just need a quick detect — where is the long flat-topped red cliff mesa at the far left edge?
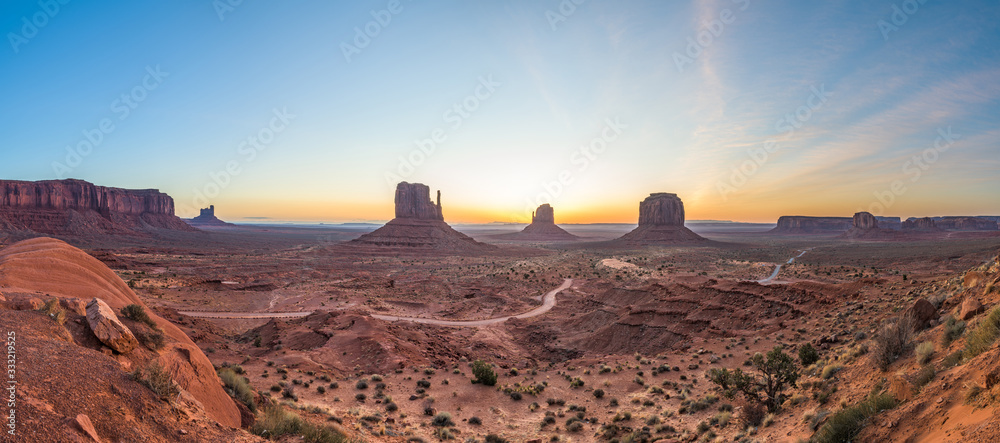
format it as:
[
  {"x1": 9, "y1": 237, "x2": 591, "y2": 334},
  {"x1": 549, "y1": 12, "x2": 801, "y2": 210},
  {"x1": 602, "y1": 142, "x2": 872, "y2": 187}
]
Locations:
[{"x1": 0, "y1": 180, "x2": 196, "y2": 235}]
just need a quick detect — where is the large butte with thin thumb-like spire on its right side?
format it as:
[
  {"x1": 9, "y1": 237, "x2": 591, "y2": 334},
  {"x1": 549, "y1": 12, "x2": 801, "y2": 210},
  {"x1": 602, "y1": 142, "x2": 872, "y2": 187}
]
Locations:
[{"x1": 348, "y1": 182, "x2": 498, "y2": 252}]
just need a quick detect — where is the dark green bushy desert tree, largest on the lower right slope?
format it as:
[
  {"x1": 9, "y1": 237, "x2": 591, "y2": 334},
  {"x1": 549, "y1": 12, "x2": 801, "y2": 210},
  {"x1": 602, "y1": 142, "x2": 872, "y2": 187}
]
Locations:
[{"x1": 708, "y1": 346, "x2": 799, "y2": 413}]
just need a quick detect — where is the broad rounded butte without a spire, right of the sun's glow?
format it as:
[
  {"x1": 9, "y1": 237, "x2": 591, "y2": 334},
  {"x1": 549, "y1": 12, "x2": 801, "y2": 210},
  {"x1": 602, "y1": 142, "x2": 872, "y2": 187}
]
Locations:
[{"x1": 618, "y1": 192, "x2": 706, "y2": 244}]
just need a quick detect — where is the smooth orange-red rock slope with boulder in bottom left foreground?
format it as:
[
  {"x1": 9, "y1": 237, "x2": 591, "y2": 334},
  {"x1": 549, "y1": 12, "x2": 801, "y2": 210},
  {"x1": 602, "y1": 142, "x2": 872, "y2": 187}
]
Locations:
[{"x1": 0, "y1": 238, "x2": 250, "y2": 442}]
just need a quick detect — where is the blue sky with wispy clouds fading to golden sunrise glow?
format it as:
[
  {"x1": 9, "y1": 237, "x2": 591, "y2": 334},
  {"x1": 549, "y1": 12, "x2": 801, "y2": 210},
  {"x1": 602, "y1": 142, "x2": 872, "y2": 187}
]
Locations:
[{"x1": 0, "y1": 0, "x2": 1000, "y2": 223}]
